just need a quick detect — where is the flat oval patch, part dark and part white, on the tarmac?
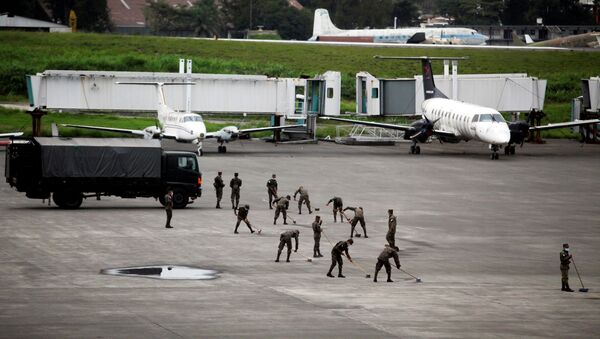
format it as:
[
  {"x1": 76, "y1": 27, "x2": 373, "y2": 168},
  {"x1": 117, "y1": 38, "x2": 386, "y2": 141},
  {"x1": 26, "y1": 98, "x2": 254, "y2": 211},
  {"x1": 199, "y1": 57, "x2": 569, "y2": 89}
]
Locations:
[{"x1": 100, "y1": 265, "x2": 217, "y2": 280}]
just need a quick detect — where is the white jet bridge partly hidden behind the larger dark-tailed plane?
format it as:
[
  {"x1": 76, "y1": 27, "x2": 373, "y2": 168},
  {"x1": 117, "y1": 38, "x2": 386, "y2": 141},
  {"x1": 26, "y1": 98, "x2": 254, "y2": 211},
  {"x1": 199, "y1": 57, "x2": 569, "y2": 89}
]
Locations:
[{"x1": 356, "y1": 72, "x2": 547, "y2": 116}]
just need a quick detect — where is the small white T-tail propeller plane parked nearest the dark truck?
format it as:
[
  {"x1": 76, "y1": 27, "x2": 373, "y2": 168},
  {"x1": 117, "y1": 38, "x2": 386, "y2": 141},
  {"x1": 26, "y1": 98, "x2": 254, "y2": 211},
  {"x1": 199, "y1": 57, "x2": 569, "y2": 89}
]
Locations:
[{"x1": 61, "y1": 82, "x2": 306, "y2": 155}]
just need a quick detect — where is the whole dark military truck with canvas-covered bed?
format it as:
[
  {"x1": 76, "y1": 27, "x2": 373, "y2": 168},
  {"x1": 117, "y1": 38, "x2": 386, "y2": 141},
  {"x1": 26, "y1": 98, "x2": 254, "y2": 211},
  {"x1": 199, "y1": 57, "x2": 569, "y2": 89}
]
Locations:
[{"x1": 5, "y1": 137, "x2": 202, "y2": 209}]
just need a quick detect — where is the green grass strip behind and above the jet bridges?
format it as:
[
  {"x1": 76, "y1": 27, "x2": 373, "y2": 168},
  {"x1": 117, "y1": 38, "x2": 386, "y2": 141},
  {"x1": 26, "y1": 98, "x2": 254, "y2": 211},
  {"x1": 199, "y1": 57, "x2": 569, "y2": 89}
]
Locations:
[{"x1": 0, "y1": 32, "x2": 600, "y2": 103}]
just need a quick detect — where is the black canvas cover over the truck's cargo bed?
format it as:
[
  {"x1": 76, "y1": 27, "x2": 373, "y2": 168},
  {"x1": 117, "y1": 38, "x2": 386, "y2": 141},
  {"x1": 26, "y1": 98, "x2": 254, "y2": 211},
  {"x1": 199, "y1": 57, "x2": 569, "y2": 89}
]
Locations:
[{"x1": 35, "y1": 138, "x2": 162, "y2": 178}]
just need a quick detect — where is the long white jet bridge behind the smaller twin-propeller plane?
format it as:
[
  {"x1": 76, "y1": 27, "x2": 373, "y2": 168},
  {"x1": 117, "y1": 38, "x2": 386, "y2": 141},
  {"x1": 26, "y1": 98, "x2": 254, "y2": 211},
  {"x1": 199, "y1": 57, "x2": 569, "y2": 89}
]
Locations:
[{"x1": 27, "y1": 70, "x2": 341, "y2": 118}]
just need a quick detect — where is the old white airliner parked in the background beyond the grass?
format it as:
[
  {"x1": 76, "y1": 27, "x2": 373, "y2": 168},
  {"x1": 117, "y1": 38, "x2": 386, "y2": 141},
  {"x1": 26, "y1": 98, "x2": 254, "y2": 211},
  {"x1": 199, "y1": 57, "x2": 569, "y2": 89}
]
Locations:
[{"x1": 309, "y1": 8, "x2": 488, "y2": 45}]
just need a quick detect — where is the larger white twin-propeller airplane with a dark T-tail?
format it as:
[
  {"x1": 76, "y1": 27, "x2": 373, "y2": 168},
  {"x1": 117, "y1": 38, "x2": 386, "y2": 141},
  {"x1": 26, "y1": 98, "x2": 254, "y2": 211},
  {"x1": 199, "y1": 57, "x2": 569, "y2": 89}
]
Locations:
[{"x1": 321, "y1": 56, "x2": 600, "y2": 160}]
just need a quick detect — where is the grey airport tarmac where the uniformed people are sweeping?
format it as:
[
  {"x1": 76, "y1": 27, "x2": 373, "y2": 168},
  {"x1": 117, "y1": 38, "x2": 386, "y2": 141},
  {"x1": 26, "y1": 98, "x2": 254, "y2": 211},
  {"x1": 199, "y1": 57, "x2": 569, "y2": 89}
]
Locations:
[{"x1": 0, "y1": 140, "x2": 600, "y2": 338}]
